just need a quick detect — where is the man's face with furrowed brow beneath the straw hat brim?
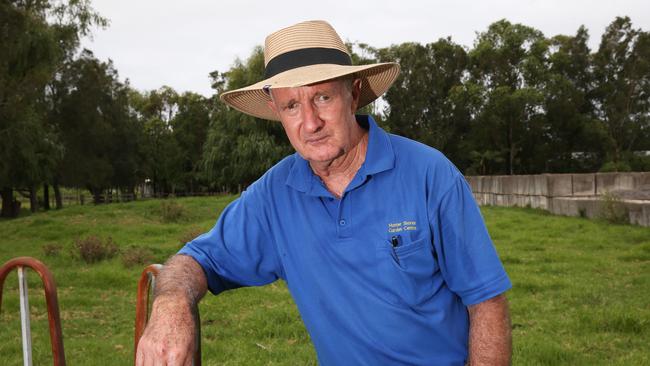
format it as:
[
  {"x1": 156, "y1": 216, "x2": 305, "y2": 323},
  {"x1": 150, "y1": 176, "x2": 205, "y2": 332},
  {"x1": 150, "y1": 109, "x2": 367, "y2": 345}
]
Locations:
[{"x1": 269, "y1": 80, "x2": 361, "y2": 163}]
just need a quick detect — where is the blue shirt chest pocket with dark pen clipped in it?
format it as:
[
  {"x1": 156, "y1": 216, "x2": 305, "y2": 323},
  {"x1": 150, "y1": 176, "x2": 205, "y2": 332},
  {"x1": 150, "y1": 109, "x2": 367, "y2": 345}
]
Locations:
[{"x1": 376, "y1": 237, "x2": 439, "y2": 306}]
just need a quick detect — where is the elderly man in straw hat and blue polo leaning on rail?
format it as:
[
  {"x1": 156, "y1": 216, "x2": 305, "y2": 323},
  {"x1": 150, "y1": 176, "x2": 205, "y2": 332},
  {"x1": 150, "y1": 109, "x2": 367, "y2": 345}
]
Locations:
[{"x1": 137, "y1": 21, "x2": 511, "y2": 365}]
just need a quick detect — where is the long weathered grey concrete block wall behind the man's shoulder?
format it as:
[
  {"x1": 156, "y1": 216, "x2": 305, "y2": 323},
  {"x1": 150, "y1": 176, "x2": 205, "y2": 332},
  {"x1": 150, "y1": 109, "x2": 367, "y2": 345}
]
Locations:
[{"x1": 466, "y1": 172, "x2": 650, "y2": 226}]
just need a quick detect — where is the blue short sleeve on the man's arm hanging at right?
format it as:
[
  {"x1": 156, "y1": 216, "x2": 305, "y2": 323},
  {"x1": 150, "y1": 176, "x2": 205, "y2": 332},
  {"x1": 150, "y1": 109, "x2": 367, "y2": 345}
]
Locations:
[{"x1": 430, "y1": 174, "x2": 512, "y2": 306}]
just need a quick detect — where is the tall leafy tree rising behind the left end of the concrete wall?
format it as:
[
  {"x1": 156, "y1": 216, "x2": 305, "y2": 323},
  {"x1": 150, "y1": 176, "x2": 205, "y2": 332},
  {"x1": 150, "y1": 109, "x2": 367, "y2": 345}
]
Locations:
[{"x1": 464, "y1": 20, "x2": 548, "y2": 174}]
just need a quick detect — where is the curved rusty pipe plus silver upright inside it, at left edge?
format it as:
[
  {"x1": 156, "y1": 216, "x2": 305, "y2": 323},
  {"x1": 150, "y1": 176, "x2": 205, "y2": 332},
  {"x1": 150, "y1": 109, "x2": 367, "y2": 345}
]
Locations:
[{"x1": 0, "y1": 257, "x2": 65, "y2": 366}]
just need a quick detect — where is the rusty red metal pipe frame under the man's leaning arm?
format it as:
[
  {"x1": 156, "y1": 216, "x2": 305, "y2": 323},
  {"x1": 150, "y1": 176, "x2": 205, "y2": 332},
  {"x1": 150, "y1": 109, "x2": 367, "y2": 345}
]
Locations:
[{"x1": 133, "y1": 264, "x2": 201, "y2": 366}]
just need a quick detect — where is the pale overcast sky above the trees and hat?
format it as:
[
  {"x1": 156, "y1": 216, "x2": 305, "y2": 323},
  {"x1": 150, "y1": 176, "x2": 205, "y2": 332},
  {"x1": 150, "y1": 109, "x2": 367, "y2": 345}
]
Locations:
[{"x1": 82, "y1": 0, "x2": 650, "y2": 96}]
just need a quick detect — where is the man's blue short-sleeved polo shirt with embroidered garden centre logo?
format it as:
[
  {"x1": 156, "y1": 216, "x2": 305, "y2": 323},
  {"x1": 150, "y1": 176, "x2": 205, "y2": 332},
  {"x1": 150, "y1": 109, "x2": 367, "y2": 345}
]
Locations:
[{"x1": 180, "y1": 116, "x2": 511, "y2": 365}]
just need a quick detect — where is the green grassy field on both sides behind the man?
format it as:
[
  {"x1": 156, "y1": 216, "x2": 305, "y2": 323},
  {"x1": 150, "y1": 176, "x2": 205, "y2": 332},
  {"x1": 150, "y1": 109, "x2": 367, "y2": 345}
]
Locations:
[{"x1": 0, "y1": 197, "x2": 650, "y2": 365}]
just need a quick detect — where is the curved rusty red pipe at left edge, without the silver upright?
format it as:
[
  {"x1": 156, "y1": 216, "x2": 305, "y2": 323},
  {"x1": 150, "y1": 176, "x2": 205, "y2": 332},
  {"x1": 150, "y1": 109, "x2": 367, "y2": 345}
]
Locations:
[{"x1": 0, "y1": 257, "x2": 65, "y2": 366}]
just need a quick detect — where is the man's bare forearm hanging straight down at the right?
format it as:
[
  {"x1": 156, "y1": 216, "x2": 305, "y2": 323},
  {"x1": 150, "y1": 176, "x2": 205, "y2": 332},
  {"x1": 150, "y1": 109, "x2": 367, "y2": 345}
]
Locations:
[{"x1": 468, "y1": 294, "x2": 512, "y2": 366}]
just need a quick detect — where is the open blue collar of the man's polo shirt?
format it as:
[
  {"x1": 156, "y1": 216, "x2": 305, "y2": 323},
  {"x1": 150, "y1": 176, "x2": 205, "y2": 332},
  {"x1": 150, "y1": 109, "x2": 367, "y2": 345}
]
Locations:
[{"x1": 286, "y1": 115, "x2": 395, "y2": 196}]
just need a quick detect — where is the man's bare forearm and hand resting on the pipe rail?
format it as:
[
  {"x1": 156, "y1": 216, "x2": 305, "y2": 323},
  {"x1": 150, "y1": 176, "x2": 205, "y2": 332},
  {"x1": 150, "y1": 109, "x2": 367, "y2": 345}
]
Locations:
[{"x1": 136, "y1": 255, "x2": 208, "y2": 366}]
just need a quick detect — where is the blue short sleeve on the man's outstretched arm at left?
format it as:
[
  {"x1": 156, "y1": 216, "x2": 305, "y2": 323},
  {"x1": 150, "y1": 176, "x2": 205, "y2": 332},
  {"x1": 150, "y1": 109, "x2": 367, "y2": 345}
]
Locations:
[{"x1": 178, "y1": 187, "x2": 281, "y2": 294}]
